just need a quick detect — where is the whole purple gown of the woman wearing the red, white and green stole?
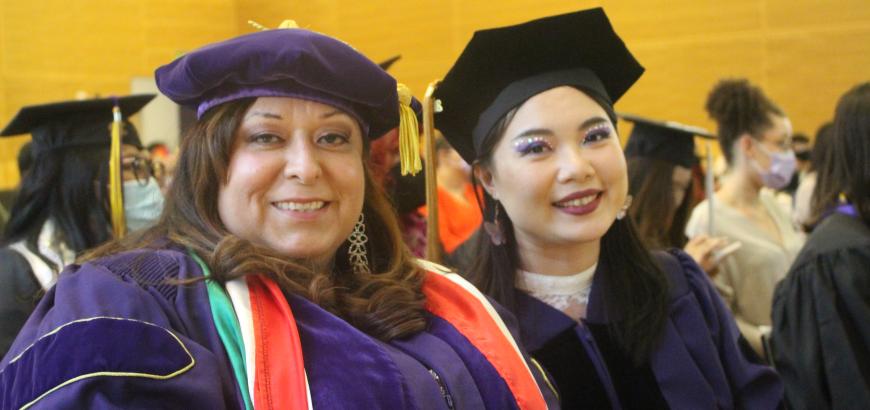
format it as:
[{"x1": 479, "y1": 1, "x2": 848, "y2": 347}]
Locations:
[{"x1": 0, "y1": 250, "x2": 557, "y2": 409}]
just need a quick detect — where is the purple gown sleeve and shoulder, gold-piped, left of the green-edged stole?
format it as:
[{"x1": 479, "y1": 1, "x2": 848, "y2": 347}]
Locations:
[{"x1": 0, "y1": 250, "x2": 242, "y2": 409}]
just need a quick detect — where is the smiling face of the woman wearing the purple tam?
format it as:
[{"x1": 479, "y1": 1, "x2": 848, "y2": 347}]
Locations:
[{"x1": 218, "y1": 97, "x2": 365, "y2": 266}]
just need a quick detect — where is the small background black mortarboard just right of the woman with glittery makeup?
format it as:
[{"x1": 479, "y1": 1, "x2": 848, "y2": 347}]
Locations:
[{"x1": 619, "y1": 113, "x2": 716, "y2": 168}]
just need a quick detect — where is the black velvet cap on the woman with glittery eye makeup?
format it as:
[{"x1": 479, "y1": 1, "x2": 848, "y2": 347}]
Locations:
[{"x1": 434, "y1": 8, "x2": 644, "y2": 163}]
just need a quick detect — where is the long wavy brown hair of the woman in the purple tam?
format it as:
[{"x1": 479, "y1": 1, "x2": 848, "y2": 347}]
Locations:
[{"x1": 83, "y1": 98, "x2": 426, "y2": 340}]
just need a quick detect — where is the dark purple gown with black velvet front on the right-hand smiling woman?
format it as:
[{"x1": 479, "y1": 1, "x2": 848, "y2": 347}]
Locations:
[{"x1": 517, "y1": 251, "x2": 782, "y2": 409}]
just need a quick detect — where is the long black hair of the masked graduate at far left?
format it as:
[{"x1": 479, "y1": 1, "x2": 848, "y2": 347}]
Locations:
[{"x1": 3, "y1": 146, "x2": 111, "y2": 269}]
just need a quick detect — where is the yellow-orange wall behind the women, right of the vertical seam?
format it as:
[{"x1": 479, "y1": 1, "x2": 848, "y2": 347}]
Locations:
[{"x1": 239, "y1": 0, "x2": 870, "y2": 149}]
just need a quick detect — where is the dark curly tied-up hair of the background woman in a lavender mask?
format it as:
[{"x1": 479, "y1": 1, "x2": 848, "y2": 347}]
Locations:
[{"x1": 705, "y1": 78, "x2": 784, "y2": 164}]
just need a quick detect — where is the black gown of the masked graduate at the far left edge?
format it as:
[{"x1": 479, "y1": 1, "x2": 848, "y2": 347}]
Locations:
[{"x1": 0, "y1": 248, "x2": 43, "y2": 357}]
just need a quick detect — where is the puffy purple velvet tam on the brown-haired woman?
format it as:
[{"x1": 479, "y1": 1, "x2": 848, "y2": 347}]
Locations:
[{"x1": 155, "y1": 29, "x2": 399, "y2": 139}]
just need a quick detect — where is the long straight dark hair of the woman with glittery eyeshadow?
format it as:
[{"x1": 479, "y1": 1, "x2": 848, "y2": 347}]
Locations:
[{"x1": 468, "y1": 88, "x2": 668, "y2": 364}]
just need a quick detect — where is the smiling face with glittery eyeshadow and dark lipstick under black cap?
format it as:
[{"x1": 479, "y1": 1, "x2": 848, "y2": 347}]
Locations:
[{"x1": 477, "y1": 87, "x2": 628, "y2": 249}]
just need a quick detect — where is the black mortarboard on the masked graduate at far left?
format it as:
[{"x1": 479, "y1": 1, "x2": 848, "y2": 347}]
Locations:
[{"x1": 0, "y1": 94, "x2": 156, "y2": 155}]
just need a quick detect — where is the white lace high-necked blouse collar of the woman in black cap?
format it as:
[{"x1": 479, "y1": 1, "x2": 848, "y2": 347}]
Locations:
[{"x1": 517, "y1": 264, "x2": 598, "y2": 321}]
